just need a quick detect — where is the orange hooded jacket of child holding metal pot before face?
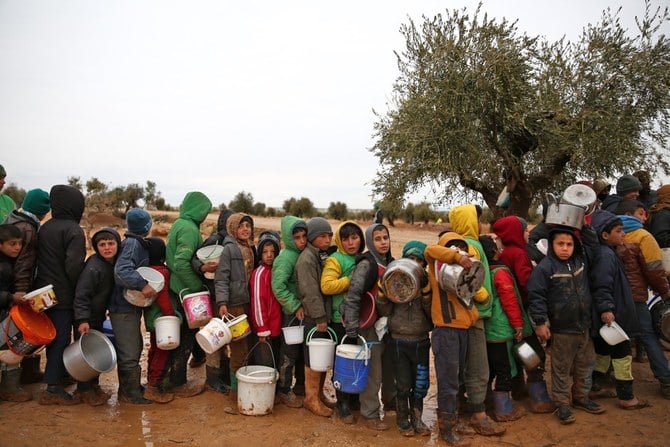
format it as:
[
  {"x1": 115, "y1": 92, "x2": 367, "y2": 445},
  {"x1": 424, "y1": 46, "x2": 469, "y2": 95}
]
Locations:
[{"x1": 425, "y1": 233, "x2": 491, "y2": 329}]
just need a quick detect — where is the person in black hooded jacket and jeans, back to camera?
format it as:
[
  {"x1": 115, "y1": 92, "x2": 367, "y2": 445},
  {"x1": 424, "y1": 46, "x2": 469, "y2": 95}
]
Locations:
[{"x1": 33, "y1": 185, "x2": 86, "y2": 405}]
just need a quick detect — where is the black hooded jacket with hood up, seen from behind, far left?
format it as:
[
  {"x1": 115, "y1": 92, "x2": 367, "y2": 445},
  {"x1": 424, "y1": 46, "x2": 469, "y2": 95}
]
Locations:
[{"x1": 33, "y1": 185, "x2": 86, "y2": 309}]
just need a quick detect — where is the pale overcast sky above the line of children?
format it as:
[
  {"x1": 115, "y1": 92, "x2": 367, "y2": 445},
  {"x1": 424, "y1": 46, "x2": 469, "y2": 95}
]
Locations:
[{"x1": 0, "y1": 0, "x2": 667, "y2": 208}]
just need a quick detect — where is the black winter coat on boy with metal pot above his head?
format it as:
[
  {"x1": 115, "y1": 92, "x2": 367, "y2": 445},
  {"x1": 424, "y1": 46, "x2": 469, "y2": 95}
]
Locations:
[{"x1": 528, "y1": 227, "x2": 592, "y2": 334}]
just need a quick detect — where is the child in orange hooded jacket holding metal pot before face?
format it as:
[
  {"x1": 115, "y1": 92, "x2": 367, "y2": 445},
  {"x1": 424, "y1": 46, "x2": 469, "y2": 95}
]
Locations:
[{"x1": 425, "y1": 232, "x2": 489, "y2": 445}]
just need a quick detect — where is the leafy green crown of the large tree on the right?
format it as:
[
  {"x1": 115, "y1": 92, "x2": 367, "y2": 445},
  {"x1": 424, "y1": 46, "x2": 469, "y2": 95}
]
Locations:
[{"x1": 371, "y1": 2, "x2": 670, "y2": 217}]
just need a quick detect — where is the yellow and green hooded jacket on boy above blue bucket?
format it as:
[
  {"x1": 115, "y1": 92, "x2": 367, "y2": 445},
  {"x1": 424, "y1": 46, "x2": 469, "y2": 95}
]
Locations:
[{"x1": 321, "y1": 220, "x2": 365, "y2": 323}]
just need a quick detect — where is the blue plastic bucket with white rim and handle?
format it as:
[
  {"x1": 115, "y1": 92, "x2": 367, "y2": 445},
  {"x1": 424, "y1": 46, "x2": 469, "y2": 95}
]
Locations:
[{"x1": 333, "y1": 335, "x2": 370, "y2": 394}]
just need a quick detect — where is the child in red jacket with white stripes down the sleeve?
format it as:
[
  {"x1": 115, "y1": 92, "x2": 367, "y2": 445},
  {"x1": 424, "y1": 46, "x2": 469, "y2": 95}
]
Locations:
[{"x1": 249, "y1": 231, "x2": 282, "y2": 369}]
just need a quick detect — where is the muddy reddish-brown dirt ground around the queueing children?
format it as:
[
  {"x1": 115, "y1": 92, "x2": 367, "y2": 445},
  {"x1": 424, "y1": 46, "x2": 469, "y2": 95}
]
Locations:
[{"x1": 0, "y1": 215, "x2": 670, "y2": 447}]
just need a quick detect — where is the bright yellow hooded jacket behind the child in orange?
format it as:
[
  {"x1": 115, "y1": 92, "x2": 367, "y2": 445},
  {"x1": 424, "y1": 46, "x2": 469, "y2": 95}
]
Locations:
[{"x1": 449, "y1": 205, "x2": 493, "y2": 318}]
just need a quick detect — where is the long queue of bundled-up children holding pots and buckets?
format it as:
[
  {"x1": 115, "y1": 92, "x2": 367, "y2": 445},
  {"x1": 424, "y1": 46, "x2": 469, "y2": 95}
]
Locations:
[{"x1": 0, "y1": 164, "x2": 670, "y2": 445}]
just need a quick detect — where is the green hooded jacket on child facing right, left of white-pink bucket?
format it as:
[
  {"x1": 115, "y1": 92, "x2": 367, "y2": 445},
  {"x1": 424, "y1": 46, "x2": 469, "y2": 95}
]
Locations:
[{"x1": 165, "y1": 191, "x2": 212, "y2": 295}]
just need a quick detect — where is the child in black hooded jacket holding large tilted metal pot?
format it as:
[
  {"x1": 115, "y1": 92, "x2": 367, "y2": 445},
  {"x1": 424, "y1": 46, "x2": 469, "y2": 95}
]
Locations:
[{"x1": 74, "y1": 228, "x2": 121, "y2": 406}]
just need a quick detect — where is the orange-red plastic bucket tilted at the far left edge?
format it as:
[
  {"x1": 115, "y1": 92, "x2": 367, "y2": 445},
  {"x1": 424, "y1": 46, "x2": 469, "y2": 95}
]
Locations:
[{"x1": 0, "y1": 304, "x2": 56, "y2": 355}]
